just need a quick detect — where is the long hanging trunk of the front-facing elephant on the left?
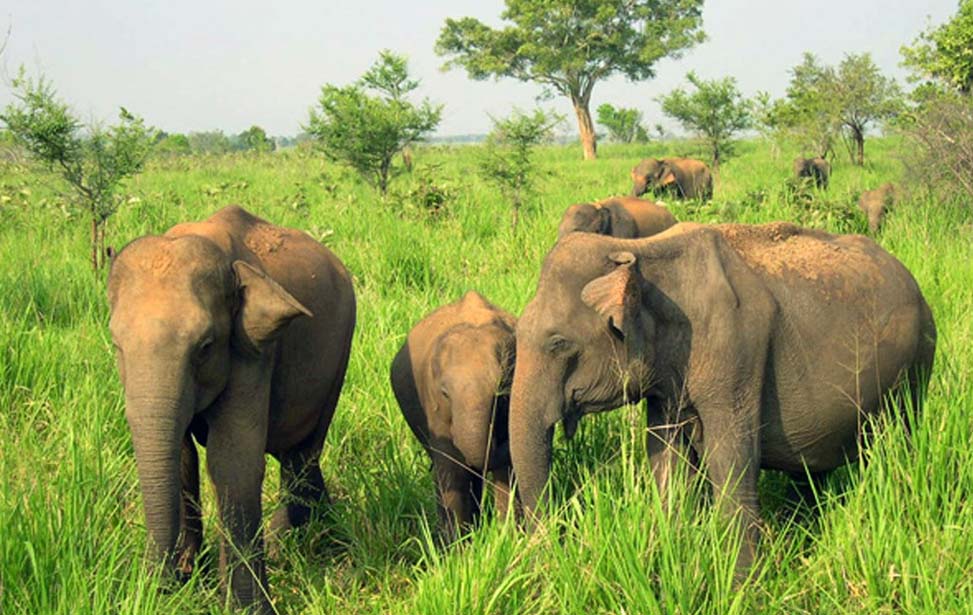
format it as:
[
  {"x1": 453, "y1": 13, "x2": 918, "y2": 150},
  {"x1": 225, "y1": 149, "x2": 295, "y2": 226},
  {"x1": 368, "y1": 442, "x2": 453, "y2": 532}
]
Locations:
[{"x1": 125, "y1": 384, "x2": 192, "y2": 573}]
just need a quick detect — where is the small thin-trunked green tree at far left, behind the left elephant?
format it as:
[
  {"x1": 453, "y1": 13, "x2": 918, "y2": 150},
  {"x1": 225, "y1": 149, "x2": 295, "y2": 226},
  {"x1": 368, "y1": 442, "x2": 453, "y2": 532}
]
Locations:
[{"x1": 0, "y1": 68, "x2": 154, "y2": 269}]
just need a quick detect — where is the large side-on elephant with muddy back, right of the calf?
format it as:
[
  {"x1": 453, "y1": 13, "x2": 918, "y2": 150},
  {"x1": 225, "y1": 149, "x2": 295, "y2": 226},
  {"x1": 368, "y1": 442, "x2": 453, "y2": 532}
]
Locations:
[{"x1": 510, "y1": 223, "x2": 936, "y2": 571}]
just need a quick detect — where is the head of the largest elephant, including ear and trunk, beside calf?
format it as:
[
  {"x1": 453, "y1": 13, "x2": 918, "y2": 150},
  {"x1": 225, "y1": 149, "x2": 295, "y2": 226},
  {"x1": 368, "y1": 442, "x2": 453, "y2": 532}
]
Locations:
[{"x1": 510, "y1": 234, "x2": 655, "y2": 512}]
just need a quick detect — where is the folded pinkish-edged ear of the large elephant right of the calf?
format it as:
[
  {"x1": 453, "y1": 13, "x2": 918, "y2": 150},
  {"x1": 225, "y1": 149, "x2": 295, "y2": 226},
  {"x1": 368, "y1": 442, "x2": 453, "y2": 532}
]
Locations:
[{"x1": 581, "y1": 252, "x2": 642, "y2": 345}]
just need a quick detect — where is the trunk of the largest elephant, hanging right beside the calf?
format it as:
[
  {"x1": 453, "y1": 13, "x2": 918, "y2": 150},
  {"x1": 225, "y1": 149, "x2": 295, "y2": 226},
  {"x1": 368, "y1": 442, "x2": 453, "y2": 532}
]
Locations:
[{"x1": 510, "y1": 355, "x2": 562, "y2": 525}]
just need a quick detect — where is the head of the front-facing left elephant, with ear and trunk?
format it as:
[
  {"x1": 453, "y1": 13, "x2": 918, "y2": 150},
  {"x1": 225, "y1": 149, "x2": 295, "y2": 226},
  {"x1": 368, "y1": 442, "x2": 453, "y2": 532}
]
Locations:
[{"x1": 108, "y1": 235, "x2": 309, "y2": 569}]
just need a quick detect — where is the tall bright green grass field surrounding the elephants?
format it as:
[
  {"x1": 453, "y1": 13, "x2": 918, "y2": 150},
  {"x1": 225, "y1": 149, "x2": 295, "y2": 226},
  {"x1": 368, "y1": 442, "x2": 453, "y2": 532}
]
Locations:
[{"x1": 0, "y1": 139, "x2": 973, "y2": 615}]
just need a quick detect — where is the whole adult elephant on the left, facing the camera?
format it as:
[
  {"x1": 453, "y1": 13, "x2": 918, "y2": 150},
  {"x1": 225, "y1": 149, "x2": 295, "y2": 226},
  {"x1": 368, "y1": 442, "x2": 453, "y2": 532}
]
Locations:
[{"x1": 108, "y1": 206, "x2": 356, "y2": 613}]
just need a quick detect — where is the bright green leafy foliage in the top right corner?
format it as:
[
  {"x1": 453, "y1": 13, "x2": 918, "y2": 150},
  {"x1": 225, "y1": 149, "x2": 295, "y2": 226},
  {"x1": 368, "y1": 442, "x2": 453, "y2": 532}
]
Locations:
[{"x1": 901, "y1": 0, "x2": 973, "y2": 94}]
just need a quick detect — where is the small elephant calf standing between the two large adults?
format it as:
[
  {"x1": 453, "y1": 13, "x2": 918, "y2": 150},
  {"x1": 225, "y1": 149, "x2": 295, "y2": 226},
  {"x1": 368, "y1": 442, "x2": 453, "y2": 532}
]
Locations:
[{"x1": 391, "y1": 291, "x2": 516, "y2": 543}]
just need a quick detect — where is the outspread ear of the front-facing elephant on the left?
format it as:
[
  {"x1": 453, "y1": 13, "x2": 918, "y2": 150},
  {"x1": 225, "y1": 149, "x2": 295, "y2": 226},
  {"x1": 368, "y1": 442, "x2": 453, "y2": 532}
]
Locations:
[{"x1": 233, "y1": 260, "x2": 313, "y2": 350}]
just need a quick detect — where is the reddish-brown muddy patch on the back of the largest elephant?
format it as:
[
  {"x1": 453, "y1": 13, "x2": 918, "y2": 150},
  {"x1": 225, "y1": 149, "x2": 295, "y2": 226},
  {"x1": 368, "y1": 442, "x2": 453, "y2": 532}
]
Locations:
[{"x1": 716, "y1": 222, "x2": 882, "y2": 294}]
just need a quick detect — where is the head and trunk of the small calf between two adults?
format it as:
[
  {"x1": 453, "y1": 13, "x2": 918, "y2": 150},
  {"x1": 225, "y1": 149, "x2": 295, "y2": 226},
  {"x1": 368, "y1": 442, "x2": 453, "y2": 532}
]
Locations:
[{"x1": 431, "y1": 320, "x2": 515, "y2": 471}]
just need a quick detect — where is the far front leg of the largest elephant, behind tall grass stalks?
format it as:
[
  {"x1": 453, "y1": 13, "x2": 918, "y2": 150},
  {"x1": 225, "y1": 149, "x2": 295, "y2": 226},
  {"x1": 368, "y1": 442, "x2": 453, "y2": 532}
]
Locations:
[{"x1": 644, "y1": 400, "x2": 696, "y2": 499}]
